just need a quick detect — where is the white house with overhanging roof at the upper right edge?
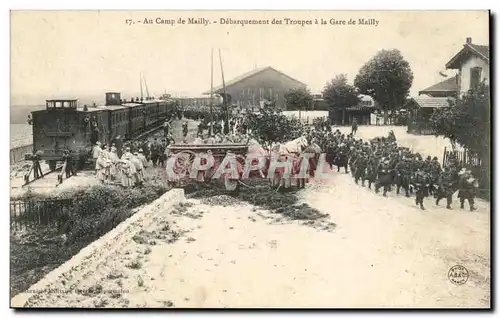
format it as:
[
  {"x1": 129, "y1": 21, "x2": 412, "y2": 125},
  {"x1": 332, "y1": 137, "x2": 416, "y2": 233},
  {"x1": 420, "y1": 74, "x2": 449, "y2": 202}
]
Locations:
[{"x1": 446, "y1": 38, "x2": 490, "y2": 94}]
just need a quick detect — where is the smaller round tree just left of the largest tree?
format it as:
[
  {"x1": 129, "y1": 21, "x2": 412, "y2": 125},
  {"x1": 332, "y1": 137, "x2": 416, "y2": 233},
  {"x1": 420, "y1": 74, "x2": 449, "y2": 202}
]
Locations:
[{"x1": 323, "y1": 74, "x2": 359, "y2": 125}]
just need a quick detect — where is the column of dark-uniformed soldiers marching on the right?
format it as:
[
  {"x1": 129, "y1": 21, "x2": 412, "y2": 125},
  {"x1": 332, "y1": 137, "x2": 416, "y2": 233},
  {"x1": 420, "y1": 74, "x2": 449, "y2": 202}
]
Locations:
[{"x1": 308, "y1": 128, "x2": 477, "y2": 211}]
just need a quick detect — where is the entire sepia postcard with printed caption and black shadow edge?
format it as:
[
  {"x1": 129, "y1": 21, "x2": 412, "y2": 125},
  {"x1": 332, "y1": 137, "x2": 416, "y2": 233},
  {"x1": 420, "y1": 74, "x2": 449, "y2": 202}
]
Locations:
[{"x1": 10, "y1": 11, "x2": 492, "y2": 309}]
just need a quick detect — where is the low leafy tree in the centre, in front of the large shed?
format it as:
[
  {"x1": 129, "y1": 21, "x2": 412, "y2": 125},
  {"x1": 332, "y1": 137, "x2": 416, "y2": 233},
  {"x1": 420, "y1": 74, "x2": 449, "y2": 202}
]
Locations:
[{"x1": 245, "y1": 107, "x2": 305, "y2": 149}]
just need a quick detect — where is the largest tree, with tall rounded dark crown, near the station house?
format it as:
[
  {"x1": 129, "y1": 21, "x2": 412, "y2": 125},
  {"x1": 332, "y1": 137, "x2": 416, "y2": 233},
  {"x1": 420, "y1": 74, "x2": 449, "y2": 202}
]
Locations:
[{"x1": 354, "y1": 49, "x2": 413, "y2": 125}]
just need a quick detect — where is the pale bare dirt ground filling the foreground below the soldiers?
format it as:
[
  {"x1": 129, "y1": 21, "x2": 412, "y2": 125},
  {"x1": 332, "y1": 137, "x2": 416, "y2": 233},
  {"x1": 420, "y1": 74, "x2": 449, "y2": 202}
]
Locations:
[{"x1": 17, "y1": 124, "x2": 491, "y2": 308}]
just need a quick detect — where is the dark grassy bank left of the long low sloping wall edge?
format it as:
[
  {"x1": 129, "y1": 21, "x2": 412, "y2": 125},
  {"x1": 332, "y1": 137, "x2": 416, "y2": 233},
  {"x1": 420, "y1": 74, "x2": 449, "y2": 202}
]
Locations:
[{"x1": 10, "y1": 169, "x2": 168, "y2": 297}]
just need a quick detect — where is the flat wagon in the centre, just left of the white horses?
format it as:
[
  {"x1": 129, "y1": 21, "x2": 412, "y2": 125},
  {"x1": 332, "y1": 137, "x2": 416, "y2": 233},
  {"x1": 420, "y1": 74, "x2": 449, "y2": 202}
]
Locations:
[{"x1": 167, "y1": 143, "x2": 248, "y2": 191}]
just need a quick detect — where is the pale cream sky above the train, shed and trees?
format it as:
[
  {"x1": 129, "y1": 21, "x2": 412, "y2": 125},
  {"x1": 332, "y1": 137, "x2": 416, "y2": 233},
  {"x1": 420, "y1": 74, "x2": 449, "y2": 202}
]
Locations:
[{"x1": 11, "y1": 11, "x2": 489, "y2": 104}]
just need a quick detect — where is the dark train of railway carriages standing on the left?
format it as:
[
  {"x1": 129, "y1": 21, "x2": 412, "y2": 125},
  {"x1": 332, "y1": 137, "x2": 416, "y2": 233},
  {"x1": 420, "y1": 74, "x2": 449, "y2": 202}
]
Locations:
[{"x1": 25, "y1": 93, "x2": 174, "y2": 170}]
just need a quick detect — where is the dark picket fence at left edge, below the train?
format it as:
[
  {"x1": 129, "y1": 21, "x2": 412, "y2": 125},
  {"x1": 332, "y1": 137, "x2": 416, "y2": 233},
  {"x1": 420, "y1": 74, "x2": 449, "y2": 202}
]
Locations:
[{"x1": 10, "y1": 199, "x2": 73, "y2": 231}]
